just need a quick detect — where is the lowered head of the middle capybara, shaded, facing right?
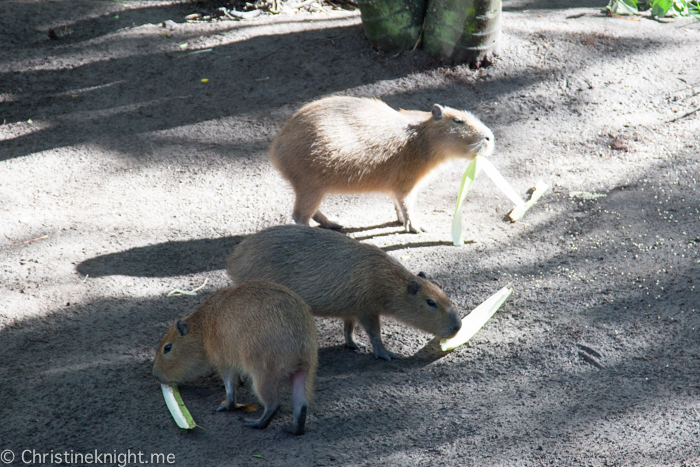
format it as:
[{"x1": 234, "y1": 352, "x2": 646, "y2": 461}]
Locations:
[{"x1": 387, "y1": 272, "x2": 462, "y2": 338}]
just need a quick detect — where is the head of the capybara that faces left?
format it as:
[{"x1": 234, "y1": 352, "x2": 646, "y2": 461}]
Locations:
[{"x1": 153, "y1": 320, "x2": 210, "y2": 385}]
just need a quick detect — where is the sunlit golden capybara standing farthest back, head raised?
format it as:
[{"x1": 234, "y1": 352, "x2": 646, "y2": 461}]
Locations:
[{"x1": 270, "y1": 97, "x2": 494, "y2": 233}]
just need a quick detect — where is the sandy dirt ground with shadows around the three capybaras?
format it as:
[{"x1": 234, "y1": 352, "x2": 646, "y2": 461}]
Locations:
[{"x1": 0, "y1": 0, "x2": 700, "y2": 466}]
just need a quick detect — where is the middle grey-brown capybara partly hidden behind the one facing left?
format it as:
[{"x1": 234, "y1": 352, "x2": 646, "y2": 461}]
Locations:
[{"x1": 227, "y1": 225, "x2": 462, "y2": 360}]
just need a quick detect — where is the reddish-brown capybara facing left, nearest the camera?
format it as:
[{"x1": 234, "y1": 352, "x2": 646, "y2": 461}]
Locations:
[{"x1": 153, "y1": 280, "x2": 318, "y2": 435}]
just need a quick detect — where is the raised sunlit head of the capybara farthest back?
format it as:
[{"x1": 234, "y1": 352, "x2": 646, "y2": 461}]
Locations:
[{"x1": 429, "y1": 104, "x2": 494, "y2": 160}]
